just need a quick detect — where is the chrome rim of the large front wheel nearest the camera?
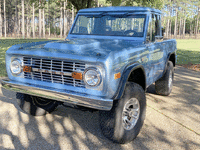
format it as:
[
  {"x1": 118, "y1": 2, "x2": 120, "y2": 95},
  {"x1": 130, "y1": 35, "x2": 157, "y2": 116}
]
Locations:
[{"x1": 122, "y1": 98, "x2": 140, "y2": 130}]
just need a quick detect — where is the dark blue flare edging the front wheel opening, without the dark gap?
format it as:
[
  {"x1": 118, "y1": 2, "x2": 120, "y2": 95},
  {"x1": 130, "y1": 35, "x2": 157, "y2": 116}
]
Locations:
[{"x1": 112, "y1": 63, "x2": 146, "y2": 100}]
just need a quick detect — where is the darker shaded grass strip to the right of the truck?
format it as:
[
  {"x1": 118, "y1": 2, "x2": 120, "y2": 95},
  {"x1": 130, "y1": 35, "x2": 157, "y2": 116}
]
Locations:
[{"x1": 176, "y1": 49, "x2": 200, "y2": 64}]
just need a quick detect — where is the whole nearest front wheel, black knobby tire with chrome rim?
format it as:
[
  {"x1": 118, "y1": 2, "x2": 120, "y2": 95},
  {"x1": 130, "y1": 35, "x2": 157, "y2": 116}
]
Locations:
[{"x1": 99, "y1": 82, "x2": 146, "y2": 143}]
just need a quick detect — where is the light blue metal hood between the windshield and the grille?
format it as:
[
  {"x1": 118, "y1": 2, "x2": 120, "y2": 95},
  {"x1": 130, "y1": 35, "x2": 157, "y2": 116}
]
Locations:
[{"x1": 7, "y1": 39, "x2": 142, "y2": 61}]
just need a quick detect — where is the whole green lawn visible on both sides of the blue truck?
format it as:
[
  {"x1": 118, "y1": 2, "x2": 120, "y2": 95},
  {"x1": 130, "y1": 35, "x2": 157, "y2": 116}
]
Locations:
[{"x1": 0, "y1": 39, "x2": 200, "y2": 77}]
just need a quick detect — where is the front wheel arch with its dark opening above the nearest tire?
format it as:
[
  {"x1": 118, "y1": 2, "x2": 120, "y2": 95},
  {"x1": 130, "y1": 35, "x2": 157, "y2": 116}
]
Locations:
[{"x1": 113, "y1": 63, "x2": 146, "y2": 100}]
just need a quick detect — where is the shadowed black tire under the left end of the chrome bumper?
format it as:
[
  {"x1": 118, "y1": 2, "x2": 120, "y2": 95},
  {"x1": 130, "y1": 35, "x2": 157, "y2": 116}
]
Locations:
[{"x1": 16, "y1": 93, "x2": 59, "y2": 116}]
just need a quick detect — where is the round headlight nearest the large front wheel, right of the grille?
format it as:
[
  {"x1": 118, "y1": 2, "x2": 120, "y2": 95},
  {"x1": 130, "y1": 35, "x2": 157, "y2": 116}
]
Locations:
[{"x1": 84, "y1": 68, "x2": 101, "y2": 86}]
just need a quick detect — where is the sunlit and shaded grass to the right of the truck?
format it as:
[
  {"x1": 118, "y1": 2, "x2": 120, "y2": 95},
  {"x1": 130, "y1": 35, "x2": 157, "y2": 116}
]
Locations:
[{"x1": 177, "y1": 39, "x2": 200, "y2": 64}]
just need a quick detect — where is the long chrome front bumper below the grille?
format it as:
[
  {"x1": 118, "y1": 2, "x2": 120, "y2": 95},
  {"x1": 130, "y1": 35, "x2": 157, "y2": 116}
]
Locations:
[{"x1": 1, "y1": 78, "x2": 113, "y2": 110}]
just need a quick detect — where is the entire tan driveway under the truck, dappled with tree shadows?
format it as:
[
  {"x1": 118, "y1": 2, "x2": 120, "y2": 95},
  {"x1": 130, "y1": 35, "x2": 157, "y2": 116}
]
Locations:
[{"x1": 0, "y1": 67, "x2": 200, "y2": 150}]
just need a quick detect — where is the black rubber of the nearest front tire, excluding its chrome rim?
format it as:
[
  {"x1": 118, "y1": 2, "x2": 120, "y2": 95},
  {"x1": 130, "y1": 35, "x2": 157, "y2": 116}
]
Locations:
[{"x1": 99, "y1": 82, "x2": 146, "y2": 144}]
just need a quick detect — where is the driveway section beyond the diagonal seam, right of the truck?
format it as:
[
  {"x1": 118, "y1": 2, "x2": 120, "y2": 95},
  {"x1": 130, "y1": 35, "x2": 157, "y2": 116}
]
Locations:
[{"x1": 146, "y1": 66, "x2": 200, "y2": 135}]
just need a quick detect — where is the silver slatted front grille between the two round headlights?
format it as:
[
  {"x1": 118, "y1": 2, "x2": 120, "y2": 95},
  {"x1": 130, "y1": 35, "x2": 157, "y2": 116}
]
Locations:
[{"x1": 23, "y1": 56, "x2": 85, "y2": 87}]
